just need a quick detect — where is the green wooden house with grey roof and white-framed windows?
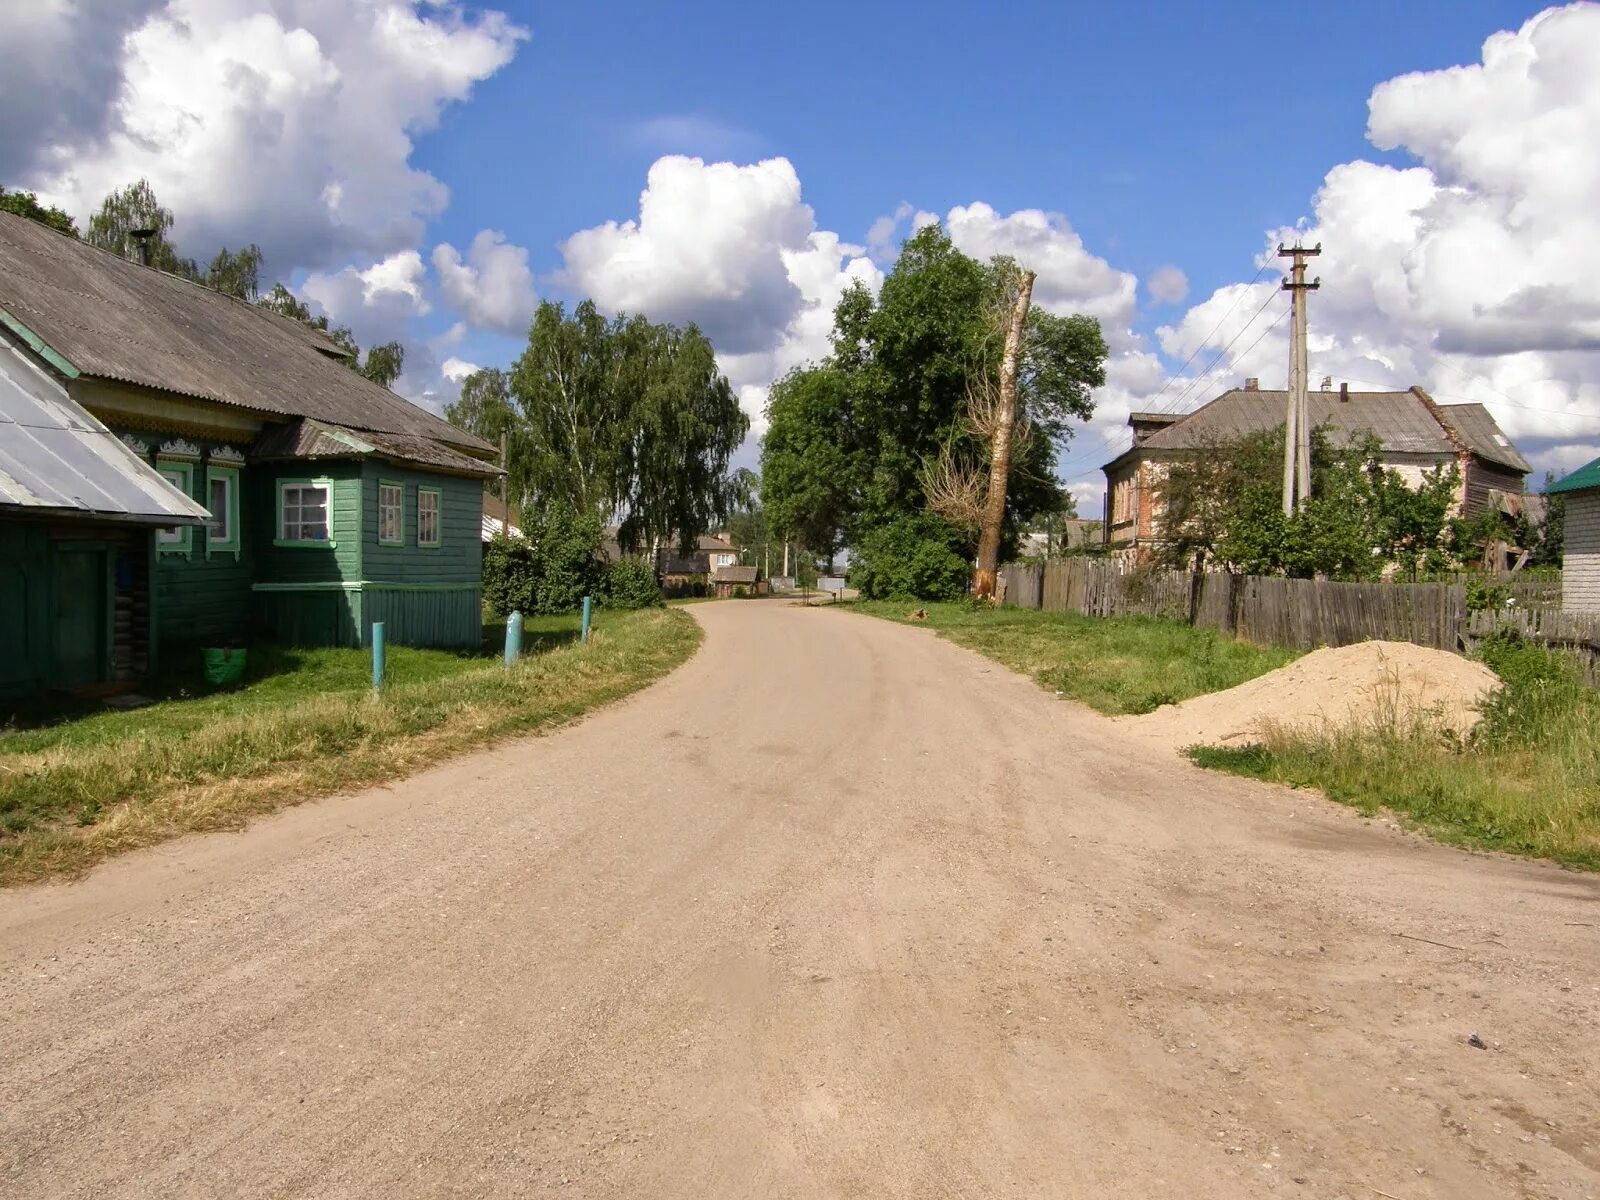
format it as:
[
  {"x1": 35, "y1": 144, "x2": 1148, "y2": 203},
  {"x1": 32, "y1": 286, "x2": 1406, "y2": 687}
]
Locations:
[{"x1": 0, "y1": 213, "x2": 499, "y2": 693}]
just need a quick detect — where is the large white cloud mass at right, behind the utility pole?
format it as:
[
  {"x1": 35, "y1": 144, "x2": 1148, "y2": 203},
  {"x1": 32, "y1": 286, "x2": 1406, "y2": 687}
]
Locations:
[{"x1": 1162, "y1": 5, "x2": 1600, "y2": 489}]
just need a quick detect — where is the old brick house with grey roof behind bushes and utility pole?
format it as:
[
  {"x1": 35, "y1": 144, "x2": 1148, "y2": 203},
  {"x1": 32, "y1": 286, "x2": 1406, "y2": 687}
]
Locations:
[{"x1": 1102, "y1": 379, "x2": 1531, "y2": 555}]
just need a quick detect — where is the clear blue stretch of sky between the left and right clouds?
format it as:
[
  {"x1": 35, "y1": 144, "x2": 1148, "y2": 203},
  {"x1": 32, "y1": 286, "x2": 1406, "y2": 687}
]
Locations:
[{"x1": 416, "y1": 0, "x2": 1541, "y2": 316}]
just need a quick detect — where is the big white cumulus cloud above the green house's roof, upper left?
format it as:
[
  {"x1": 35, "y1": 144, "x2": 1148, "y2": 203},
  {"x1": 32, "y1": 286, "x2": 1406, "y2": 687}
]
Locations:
[{"x1": 23, "y1": 0, "x2": 525, "y2": 270}]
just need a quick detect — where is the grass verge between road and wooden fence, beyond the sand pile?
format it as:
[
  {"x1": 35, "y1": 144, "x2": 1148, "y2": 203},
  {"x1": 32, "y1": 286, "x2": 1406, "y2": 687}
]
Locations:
[{"x1": 846, "y1": 600, "x2": 1298, "y2": 717}]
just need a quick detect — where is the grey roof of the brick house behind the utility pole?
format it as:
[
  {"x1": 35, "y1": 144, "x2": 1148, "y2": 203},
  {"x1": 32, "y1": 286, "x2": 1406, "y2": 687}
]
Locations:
[{"x1": 1141, "y1": 389, "x2": 1530, "y2": 472}]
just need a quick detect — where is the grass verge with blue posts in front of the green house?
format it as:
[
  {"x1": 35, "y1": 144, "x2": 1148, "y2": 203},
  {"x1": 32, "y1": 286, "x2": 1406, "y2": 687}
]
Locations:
[{"x1": 0, "y1": 608, "x2": 701, "y2": 886}]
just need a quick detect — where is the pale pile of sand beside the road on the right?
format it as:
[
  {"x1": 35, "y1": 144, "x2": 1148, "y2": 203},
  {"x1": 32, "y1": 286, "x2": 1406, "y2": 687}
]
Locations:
[{"x1": 1120, "y1": 642, "x2": 1499, "y2": 747}]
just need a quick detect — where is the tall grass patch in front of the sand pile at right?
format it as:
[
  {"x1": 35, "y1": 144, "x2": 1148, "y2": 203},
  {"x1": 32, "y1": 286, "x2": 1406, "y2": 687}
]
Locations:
[{"x1": 1189, "y1": 638, "x2": 1600, "y2": 870}]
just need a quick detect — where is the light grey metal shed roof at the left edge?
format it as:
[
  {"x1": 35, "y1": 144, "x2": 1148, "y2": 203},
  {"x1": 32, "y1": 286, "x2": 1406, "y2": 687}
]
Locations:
[{"x1": 0, "y1": 342, "x2": 210, "y2": 528}]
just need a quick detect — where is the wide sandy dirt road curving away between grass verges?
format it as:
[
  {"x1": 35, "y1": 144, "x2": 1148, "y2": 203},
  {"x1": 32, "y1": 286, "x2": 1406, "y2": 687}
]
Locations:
[{"x1": 0, "y1": 603, "x2": 1600, "y2": 1200}]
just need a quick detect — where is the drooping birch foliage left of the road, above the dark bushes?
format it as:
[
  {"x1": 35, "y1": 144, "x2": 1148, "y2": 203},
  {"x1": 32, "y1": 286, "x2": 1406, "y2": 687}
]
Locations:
[{"x1": 510, "y1": 301, "x2": 749, "y2": 552}]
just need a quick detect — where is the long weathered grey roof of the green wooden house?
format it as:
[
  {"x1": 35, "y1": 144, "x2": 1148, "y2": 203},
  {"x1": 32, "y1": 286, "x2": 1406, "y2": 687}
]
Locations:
[{"x1": 0, "y1": 213, "x2": 493, "y2": 454}]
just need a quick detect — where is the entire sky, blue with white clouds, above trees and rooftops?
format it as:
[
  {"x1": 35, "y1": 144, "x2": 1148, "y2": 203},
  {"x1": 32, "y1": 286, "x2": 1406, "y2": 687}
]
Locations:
[{"x1": 0, "y1": 0, "x2": 1600, "y2": 506}]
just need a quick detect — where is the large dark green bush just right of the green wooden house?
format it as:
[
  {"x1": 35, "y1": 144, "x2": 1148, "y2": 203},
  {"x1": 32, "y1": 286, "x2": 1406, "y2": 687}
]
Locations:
[{"x1": 483, "y1": 509, "x2": 603, "y2": 616}]
